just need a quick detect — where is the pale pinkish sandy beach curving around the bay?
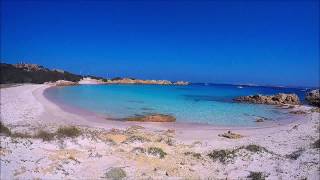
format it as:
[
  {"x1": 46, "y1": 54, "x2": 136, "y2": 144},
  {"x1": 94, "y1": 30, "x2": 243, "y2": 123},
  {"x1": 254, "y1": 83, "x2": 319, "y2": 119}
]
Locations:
[{"x1": 0, "y1": 84, "x2": 320, "y2": 179}]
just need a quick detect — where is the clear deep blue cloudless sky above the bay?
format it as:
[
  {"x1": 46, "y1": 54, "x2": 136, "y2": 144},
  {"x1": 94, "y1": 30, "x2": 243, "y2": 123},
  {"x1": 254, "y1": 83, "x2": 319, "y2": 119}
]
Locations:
[{"x1": 1, "y1": 0, "x2": 320, "y2": 86}]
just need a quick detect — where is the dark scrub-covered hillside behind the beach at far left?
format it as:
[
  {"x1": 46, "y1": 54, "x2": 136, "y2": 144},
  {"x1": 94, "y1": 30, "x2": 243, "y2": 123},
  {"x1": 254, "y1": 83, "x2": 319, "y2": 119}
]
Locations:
[{"x1": 0, "y1": 63, "x2": 82, "y2": 84}]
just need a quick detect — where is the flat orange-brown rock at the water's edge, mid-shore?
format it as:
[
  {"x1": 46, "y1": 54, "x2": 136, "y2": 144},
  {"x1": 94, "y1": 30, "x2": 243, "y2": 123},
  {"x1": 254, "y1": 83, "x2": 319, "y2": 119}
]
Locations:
[{"x1": 124, "y1": 114, "x2": 176, "y2": 122}]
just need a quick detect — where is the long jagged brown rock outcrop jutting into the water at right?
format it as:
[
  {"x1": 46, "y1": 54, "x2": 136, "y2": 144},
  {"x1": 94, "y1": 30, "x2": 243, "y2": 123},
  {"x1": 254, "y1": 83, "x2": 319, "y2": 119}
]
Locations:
[{"x1": 234, "y1": 93, "x2": 300, "y2": 105}]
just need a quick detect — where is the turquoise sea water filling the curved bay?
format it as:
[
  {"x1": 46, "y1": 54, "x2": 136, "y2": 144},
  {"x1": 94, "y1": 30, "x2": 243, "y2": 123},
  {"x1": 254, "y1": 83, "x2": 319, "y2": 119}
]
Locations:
[{"x1": 46, "y1": 84, "x2": 305, "y2": 126}]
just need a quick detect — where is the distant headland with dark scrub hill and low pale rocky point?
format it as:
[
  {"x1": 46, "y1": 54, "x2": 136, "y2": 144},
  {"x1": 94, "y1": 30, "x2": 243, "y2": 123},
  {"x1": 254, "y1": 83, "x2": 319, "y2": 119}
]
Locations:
[{"x1": 0, "y1": 63, "x2": 189, "y2": 86}]
